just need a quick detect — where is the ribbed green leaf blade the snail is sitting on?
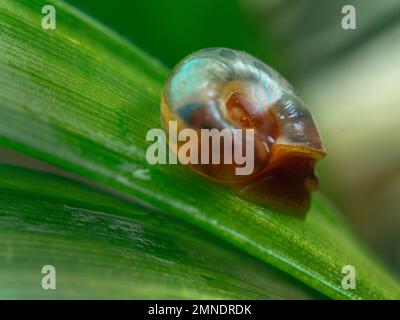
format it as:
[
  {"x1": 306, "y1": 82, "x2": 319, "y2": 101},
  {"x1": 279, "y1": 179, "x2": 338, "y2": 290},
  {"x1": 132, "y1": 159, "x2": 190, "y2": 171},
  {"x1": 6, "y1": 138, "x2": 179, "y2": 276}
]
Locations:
[{"x1": 0, "y1": 0, "x2": 400, "y2": 299}]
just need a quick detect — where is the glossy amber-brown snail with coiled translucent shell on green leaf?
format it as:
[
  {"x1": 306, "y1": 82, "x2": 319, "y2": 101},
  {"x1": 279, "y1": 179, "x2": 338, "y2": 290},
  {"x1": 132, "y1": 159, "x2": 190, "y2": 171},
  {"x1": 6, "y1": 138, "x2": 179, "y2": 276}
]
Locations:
[{"x1": 161, "y1": 48, "x2": 325, "y2": 214}]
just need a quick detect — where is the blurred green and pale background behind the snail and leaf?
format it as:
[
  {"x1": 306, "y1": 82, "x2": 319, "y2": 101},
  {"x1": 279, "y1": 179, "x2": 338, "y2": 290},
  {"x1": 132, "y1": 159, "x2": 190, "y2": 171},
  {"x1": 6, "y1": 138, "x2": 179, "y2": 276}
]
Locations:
[{"x1": 67, "y1": 0, "x2": 400, "y2": 274}]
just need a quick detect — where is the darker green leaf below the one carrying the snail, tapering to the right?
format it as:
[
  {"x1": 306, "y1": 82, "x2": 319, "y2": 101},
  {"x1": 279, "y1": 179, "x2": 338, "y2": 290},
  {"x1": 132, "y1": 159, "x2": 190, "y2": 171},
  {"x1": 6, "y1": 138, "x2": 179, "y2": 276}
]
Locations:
[{"x1": 0, "y1": 165, "x2": 315, "y2": 299}]
